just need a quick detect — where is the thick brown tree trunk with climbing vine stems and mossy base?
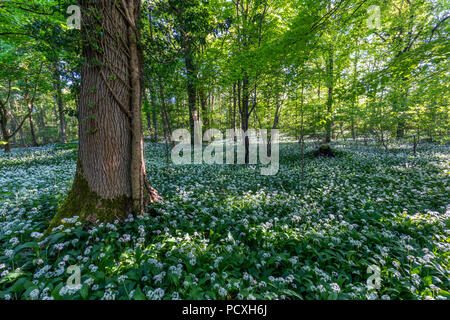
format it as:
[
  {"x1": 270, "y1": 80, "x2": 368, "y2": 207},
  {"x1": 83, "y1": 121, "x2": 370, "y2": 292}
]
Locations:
[{"x1": 50, "y1": 0, "x2": 159, "y2": 227}]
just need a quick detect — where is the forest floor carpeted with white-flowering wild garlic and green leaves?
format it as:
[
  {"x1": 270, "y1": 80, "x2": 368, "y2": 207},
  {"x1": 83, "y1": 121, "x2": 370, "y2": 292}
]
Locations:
[{"x1": 0, "y1": 143, "x2": 450, "y2": 299}]
